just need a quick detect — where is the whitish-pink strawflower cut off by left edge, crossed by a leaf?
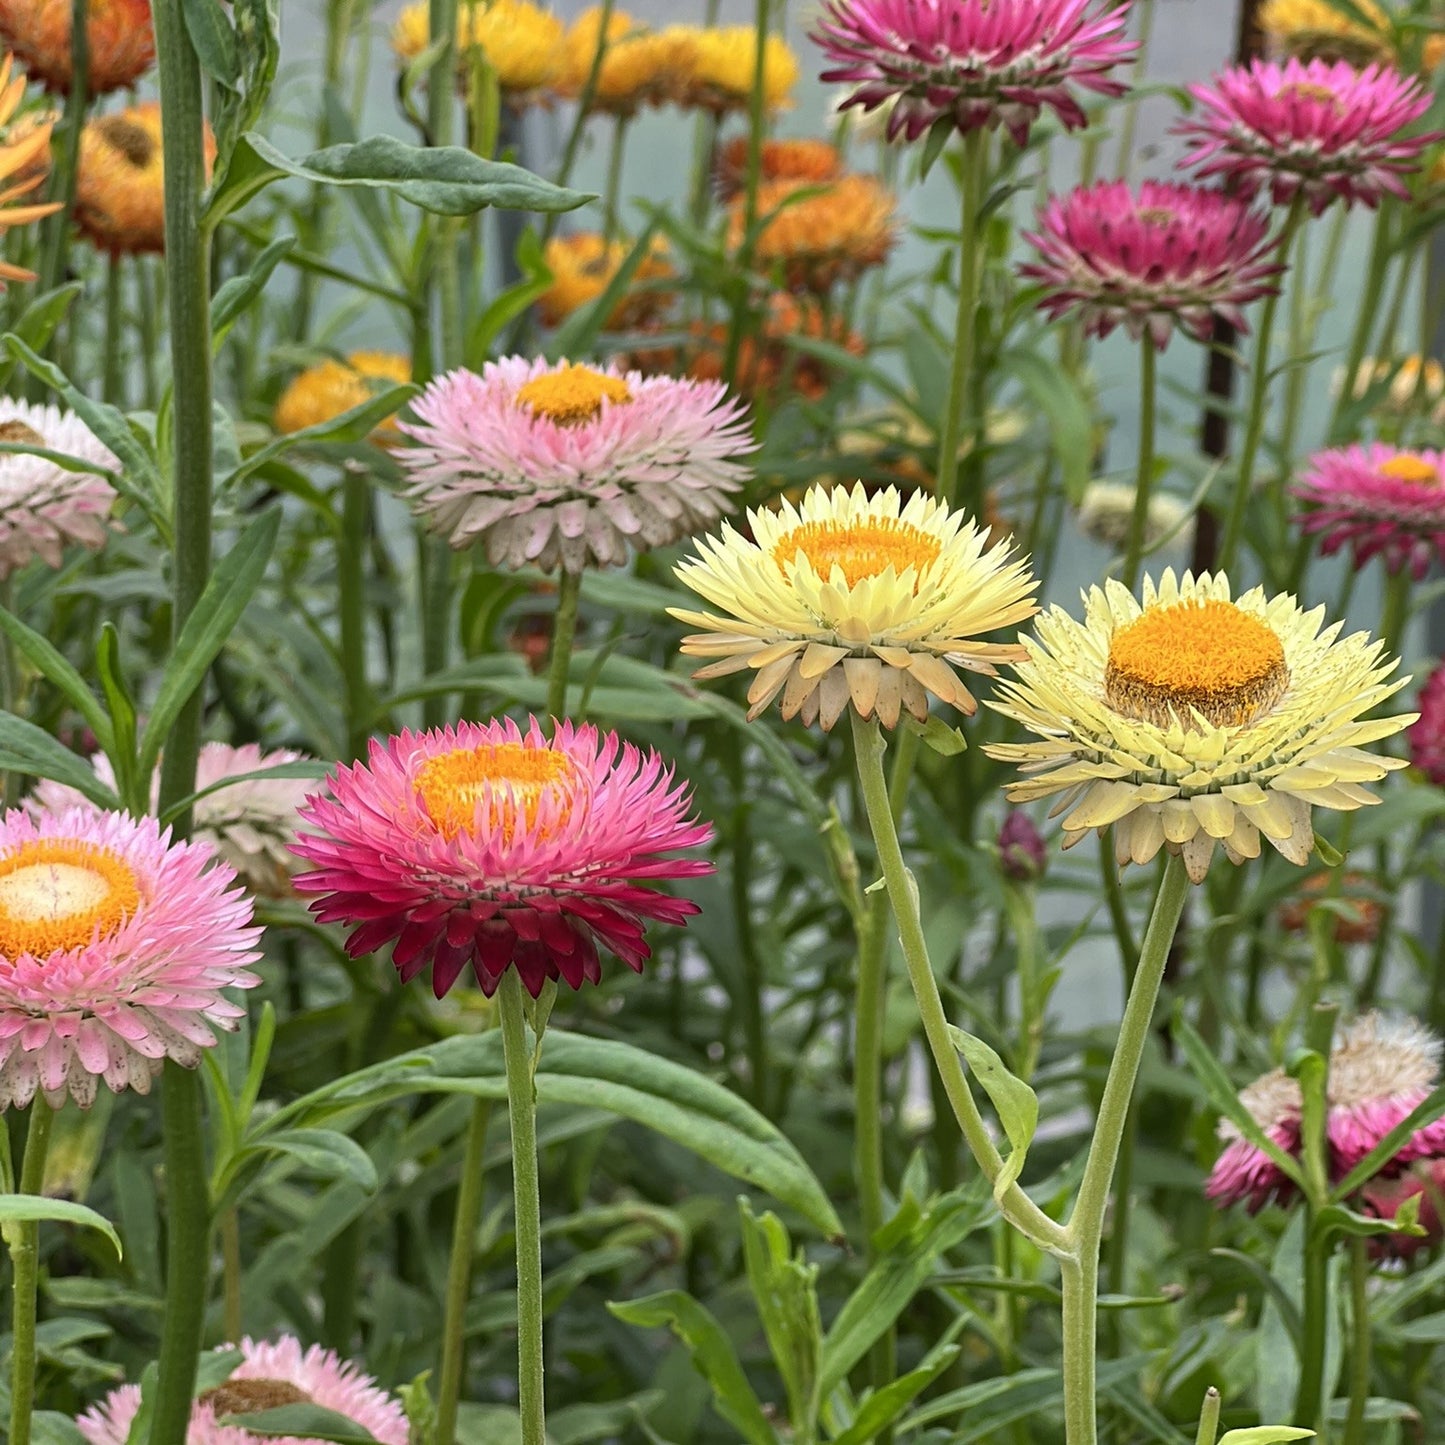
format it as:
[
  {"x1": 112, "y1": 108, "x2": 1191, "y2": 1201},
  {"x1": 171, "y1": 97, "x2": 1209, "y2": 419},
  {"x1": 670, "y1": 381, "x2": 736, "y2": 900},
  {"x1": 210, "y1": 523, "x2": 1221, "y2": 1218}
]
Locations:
[{"x1": 0, "y1": 397, "x2": 120, "y2": 578}]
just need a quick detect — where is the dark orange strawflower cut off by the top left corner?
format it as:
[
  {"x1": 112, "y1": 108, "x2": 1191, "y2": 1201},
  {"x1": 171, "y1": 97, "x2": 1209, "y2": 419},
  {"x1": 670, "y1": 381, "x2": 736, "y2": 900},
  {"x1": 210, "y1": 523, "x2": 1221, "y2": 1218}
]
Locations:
[{"x1": 0, "y1": 0, "x2": 156, "y2": 95}]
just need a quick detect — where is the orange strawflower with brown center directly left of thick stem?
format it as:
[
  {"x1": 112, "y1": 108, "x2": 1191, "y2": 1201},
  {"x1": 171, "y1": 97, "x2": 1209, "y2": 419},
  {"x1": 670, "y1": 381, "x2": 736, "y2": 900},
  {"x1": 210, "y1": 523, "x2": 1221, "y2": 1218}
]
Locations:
[{"x1": 75, "y1": 100, "x2": 215, "y2": 254}]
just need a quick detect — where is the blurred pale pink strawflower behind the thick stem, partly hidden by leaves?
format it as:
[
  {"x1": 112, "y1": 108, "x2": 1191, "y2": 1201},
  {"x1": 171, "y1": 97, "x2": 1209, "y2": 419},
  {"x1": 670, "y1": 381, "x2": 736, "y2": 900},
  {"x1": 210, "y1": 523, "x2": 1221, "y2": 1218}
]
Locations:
[{"x1": 25, "y1": 743, "x2": 311, "y2": 897}]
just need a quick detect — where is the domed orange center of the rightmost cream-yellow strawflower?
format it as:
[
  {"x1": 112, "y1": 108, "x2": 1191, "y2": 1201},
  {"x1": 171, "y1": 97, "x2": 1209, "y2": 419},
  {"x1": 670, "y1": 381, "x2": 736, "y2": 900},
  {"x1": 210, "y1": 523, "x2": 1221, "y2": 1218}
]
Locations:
[{"x1": 1104, "y1": 601, "x2": 1289, "y2": 727}]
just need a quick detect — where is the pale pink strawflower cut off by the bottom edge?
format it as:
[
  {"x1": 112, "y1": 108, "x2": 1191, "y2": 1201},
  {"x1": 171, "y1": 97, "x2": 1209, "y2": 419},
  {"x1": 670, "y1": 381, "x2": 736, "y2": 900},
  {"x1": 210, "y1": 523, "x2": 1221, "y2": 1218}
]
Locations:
[{"x1": 75, "y1": 1335, "x2": 407, "y2": 1445}]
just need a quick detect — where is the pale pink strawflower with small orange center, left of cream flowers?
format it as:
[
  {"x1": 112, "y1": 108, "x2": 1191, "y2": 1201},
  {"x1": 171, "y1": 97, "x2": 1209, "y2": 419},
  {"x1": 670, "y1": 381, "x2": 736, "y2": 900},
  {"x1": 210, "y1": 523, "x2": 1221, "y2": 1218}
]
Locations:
[{"x1": 397, "y1": 357, "x2": 754, "y2": 572}]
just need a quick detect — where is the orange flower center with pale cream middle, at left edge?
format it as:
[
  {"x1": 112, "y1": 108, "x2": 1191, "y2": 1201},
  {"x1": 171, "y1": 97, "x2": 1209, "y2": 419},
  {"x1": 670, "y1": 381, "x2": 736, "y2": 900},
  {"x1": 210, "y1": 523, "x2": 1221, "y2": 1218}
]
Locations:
[{"x1": 0, "y1": 838, "x2": 140, "y2": 959}]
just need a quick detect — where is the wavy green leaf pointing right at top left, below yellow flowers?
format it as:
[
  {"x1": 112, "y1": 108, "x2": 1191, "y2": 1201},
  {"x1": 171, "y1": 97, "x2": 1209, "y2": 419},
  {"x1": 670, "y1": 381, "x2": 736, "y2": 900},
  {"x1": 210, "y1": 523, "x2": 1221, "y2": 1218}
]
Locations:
[{"x1": 207, "y1": 131, "x2": 594, "y2": 225}]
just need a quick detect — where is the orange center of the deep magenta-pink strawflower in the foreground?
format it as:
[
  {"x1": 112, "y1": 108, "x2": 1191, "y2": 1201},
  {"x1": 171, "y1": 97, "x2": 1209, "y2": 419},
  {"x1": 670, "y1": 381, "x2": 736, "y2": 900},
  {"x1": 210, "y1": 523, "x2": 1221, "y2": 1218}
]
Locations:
[{"x1": 416, "y1": 743, "x2": 581, "y2": 842}]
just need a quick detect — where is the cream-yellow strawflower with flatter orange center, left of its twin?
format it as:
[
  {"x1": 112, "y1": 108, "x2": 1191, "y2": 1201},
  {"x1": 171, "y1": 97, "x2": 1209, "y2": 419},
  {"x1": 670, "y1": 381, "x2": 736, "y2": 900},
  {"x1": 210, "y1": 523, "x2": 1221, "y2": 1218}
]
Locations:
[{"x1": 669, "y1": 483, "x2": 1038, "y2": 731}]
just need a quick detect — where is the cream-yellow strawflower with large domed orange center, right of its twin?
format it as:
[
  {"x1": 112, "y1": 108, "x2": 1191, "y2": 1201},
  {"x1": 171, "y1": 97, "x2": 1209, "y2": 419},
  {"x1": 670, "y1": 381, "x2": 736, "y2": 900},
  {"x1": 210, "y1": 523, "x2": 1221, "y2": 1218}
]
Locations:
[{"x1": 984, "y1": 571, "x2": 1415, "y2": 883}]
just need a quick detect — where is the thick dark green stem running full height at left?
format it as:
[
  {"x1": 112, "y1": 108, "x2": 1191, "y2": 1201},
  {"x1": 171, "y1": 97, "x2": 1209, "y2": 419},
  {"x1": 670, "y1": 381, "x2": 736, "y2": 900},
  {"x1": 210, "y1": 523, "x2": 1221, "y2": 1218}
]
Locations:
[{"x1": 150, "y1": 0, "x2": 214, "y2": 1445}]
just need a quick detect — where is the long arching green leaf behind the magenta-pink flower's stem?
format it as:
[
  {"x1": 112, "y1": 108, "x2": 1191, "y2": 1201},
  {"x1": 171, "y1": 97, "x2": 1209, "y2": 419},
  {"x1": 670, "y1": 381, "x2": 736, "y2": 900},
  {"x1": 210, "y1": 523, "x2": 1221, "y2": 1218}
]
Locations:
[{"x1": 269, "y1": 1029, "x2": 842, "y2": 1238}]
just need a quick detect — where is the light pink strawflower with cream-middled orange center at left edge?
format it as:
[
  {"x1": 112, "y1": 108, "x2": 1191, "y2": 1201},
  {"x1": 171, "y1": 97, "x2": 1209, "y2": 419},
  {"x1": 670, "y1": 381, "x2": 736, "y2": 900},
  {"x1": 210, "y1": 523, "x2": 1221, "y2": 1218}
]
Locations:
[{"x1": 0, "y1": 809, "x2": 260, "y2": 1110}]
